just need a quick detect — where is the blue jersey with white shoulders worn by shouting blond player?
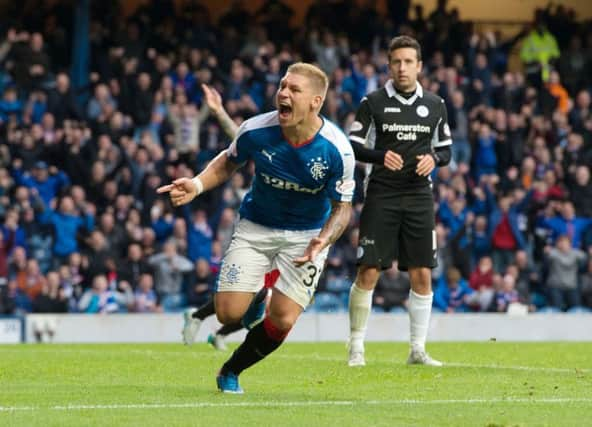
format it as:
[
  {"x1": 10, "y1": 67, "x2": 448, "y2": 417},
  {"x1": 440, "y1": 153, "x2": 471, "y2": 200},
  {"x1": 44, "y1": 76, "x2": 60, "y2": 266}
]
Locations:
[{"x1": 228, "y1": 111, "x2": 355, "y2": 230}]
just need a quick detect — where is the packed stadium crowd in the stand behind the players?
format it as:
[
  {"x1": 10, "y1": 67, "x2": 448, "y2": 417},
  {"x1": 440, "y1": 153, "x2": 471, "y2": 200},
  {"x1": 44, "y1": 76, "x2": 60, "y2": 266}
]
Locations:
[{"x1": 0, "y1": 0, "x2": 592, "y2": 314}]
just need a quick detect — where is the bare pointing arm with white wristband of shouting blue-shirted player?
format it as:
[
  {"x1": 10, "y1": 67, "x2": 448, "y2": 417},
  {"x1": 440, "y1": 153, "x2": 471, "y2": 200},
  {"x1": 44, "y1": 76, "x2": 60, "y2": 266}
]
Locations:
[{"x1": 156, "y1": 150, "x2": 240, "y2": 206}]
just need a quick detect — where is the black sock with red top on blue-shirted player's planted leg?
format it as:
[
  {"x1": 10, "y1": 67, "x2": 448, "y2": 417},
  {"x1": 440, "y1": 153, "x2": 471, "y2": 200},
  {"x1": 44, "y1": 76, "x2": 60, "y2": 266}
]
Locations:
[{"x1": 220, "y1": 317, "x2": 289, "y2": 375}]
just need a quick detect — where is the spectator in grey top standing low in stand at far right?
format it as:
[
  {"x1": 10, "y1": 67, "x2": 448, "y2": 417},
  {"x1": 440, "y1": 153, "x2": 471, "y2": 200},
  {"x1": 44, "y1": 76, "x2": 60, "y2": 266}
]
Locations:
[{"x1": 545, "y1": 235, "x2": 592, "y2": 310}]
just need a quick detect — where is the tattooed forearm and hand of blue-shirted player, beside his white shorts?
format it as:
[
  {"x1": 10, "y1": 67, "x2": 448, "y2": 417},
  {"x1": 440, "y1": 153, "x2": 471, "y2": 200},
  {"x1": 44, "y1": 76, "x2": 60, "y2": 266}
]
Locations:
[{"x1": 294, "y1": 201, "x2": 351, "y2": 266}]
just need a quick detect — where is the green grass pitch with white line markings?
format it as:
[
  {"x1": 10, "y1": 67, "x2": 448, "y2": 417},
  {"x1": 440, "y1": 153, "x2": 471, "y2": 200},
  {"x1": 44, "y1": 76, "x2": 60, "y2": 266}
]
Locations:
[{"x1": 0, "y1": 342, "x2": 592, "y2": 427}]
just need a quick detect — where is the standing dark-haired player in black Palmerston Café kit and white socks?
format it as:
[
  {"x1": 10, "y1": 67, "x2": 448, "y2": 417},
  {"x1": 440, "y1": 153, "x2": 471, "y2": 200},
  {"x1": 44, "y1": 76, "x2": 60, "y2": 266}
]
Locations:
[{"x1": 349, "y1": 36, "x2": 452, "y2": 366}]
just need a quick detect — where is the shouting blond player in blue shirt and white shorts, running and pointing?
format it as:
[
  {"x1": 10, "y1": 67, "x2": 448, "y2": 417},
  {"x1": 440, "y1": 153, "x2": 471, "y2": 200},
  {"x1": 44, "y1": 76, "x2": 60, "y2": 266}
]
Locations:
[{"x1": 158, "y1": 63, "x2": 355, "y2": 393}]
